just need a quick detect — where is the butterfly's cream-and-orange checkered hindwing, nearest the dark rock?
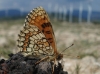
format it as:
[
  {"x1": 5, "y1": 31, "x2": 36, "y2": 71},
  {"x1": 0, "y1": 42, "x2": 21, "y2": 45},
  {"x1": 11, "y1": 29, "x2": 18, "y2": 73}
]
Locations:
[{"x1": 18, "y1": 24, "x2": 53, "y2": 55}]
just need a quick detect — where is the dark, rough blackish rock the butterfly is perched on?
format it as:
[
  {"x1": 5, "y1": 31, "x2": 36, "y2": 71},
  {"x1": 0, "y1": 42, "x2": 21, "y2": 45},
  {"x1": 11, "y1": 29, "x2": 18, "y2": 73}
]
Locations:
[{"x1": 0, "y1": 53, "x2": 68, "y2": 74}]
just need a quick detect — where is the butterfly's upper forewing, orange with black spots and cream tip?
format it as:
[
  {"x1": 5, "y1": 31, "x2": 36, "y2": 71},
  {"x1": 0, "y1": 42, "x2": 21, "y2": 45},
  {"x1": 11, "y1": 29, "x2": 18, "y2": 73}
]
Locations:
[{"x1": 26, "y1": 7, "x2": 57, "y2": 54}]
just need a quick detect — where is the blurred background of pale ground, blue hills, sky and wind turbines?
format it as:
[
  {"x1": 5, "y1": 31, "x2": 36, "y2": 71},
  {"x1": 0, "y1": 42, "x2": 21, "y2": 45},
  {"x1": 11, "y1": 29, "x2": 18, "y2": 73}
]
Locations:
[{"x1": 0, "y1": 0, "x2": 100, "y2": 74}]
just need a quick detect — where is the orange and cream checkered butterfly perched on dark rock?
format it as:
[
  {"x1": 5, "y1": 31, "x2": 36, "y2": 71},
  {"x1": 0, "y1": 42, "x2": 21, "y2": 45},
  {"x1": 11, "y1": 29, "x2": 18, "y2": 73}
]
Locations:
[{"x1": 18, "y1": 7, "x2": 63, "y2": 60}]
